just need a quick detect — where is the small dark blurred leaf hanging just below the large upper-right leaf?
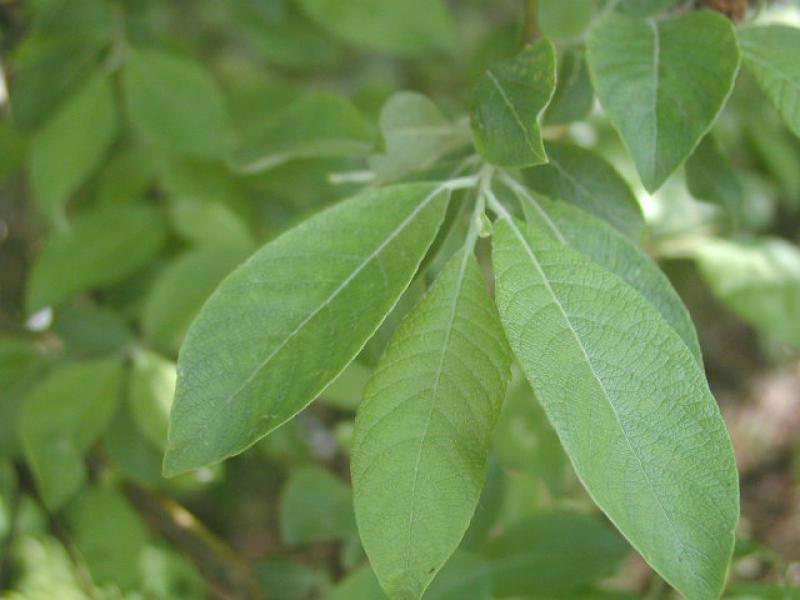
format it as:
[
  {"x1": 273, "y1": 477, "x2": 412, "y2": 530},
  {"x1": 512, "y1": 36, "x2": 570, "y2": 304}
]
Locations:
[{"x1": 686, "y1": 134, "x2": 745, "y2": 223}]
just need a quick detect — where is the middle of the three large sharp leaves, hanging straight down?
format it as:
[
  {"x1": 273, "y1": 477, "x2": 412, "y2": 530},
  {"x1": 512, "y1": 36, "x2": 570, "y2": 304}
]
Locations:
[{"x1": 351, "y1": 246, "x2": 511, "y2": 600}]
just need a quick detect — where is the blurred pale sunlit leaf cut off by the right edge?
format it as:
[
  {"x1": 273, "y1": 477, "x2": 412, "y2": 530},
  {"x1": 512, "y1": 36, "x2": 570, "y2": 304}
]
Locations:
[{"x1": 696, "y1": 238, "x2": 800, "y2": 348}]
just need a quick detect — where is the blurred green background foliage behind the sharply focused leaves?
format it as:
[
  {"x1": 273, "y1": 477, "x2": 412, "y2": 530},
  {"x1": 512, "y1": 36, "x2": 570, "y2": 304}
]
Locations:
[{"x1": 0, "y1": 0, "x2": 800, "y2": 600}]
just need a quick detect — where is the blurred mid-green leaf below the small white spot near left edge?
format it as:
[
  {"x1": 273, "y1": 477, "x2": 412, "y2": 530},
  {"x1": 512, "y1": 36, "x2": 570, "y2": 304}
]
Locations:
[{"x1": 19, "y1": 359, "x2": 122, "y2": 510}]
